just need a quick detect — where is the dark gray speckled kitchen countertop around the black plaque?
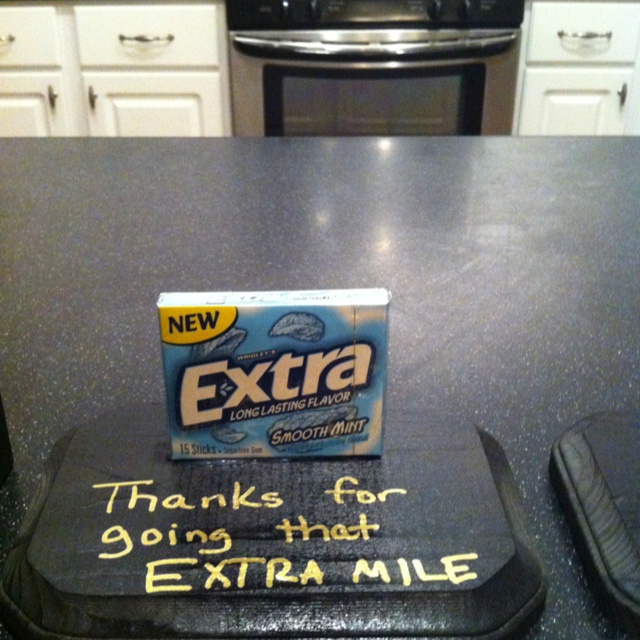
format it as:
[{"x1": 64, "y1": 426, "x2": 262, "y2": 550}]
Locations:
[{"x1": 0, "y1": 138, "x2": 640, "y2": 640}]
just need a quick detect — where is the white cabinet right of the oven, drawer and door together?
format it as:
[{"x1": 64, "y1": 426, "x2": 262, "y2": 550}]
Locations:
[{"x1": 518, "y1": 2, "x2": 640, "y2": 135}]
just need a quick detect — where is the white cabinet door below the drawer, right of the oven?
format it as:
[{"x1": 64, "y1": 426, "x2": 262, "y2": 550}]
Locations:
[{"x1": 519, "y1": 67, "x2": 633, "y2": 135}]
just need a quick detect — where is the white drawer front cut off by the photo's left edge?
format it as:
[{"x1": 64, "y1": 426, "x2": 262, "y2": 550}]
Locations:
[{"x1": 0, "y1": 7, "x2": 60, "y2": 67}]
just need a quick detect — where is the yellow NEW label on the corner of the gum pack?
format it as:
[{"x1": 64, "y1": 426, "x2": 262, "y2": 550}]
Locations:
[{"x1": 158, "y1": 307, "x2": 238, "y2": 344}]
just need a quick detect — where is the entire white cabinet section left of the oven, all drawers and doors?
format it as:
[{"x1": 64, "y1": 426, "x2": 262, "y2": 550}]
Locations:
[{"x1": 0, "y1": 0, "x2": 231, "y2": 136}]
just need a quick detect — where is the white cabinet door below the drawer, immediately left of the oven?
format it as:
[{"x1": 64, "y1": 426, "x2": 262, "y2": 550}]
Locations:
[{"x1": 83, "y1": 71, "x2": 224, "y2": 137}]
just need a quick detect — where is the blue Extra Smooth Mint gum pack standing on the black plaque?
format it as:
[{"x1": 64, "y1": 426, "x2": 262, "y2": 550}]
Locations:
[{"x1": 158, "y1": 289, "x2": 390, "y2": 459}]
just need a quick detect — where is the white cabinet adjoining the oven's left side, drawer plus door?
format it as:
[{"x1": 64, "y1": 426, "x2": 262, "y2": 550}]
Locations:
[{"x1": 75, "y1": 5, "x2": 229, "y2": 136}]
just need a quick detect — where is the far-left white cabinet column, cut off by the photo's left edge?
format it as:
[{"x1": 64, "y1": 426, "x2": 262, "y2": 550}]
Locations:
[{"x1": 0, "y1": 7, "x2": 69, "y2": 136}]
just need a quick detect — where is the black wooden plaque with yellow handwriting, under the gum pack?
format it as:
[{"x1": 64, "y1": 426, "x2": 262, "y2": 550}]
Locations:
[{"x1": 0, "y1": 405, "x2": 546, "y2": 639}]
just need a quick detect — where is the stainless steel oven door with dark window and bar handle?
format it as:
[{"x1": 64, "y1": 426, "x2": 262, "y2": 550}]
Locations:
[{"x1": 230, "y1": 29, "x2": 519, "y2": 136}]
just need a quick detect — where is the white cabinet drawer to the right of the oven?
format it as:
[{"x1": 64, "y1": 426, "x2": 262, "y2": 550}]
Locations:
[{"x1": 527, "y1": 2, "x2": 640, "y2": 64}]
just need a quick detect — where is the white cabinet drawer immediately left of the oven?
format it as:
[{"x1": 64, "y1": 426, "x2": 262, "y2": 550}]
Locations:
[{"x1": 75, "y1": 5, "x2": 218, "y2": 67}]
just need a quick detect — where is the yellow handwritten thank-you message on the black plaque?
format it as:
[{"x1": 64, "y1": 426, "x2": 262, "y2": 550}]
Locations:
[{"x1": 92, "y1": 472, "x2": 478, "y2": 593}]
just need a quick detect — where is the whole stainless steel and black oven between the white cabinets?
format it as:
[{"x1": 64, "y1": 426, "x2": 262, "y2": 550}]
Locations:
[{"x1": 227, "y1": 0, "x2": 524, "y2": 136}]
